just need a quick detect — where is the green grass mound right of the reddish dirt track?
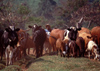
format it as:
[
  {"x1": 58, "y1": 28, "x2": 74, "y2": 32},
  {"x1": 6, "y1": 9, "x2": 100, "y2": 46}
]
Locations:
[{"x1": 28, "y1": 55, "x2": 100, "y2": 71}]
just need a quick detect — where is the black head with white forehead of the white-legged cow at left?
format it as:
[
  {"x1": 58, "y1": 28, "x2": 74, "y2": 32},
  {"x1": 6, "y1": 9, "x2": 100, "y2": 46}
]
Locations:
[{"x1": 5, "y1": 26, "x2": 20, "y2": 41}]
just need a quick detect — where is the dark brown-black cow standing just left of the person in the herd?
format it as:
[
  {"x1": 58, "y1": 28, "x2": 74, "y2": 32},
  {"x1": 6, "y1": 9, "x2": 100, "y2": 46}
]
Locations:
[{"x1": 29, "y1": 24, "x2": 46, "y2": 58}]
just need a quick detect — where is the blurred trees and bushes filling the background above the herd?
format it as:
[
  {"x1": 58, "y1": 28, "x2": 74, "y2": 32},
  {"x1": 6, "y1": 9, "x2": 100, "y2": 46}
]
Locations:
[{"x1": 0, "y1": 0, "x2": 100, "y2": 29}]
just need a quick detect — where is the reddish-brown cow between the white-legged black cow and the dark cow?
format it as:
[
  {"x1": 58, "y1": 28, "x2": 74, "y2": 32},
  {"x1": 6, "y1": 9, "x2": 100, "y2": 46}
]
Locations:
[{"x1": 17, "y1": 29, "x2": 35, "y2": 58}]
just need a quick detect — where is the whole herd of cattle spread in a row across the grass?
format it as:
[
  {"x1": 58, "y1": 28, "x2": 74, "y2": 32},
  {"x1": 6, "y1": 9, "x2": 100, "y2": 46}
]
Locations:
[{"x1": 0, "y1": 24, "x2": 100, "y2": 66}]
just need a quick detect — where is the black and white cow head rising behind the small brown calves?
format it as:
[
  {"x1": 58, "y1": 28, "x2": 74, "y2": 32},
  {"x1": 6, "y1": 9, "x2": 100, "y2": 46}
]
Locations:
[{"x1": 64, "y1": 27, "x2": 81, "y2": 40}]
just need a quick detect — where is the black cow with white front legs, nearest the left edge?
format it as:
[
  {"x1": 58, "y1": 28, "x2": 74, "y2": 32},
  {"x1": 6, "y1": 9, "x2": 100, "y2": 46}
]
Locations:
[{"x1": 1, "y1": 26, "x2": 20, "y2": 65}]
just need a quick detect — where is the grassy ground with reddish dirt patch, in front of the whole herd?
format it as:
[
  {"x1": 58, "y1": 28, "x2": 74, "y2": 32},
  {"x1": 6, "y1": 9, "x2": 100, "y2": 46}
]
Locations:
[{"x1": 0, "y1": 51, "x2": 100, "y2": 71}]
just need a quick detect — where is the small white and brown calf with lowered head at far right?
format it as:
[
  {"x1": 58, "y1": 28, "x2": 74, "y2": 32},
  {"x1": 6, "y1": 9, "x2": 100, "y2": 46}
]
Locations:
[{"x1": 86, "y1": 41, "x2": 100, "y2": 60}]
